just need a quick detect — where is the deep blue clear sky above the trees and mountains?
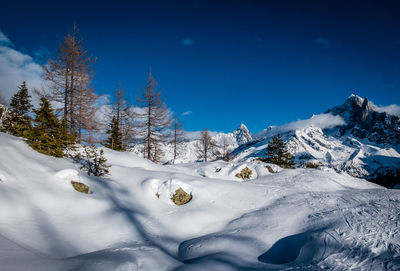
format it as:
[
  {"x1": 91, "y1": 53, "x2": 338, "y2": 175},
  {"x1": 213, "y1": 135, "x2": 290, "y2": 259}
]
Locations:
[{"x1": 0, "y1": 1, "x2": 400, "y2": 132}]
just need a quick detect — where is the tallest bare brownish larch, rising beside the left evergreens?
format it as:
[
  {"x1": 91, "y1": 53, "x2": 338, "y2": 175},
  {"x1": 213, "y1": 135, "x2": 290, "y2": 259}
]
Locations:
[{"x1": 42, "y1": 25, "x2": 97, "y2": 142}]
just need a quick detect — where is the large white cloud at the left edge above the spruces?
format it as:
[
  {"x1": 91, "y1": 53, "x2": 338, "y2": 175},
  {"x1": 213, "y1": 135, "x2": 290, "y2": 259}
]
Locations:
[{"x1": 0, "y1": 30, "x2": 43, "y2": 105}]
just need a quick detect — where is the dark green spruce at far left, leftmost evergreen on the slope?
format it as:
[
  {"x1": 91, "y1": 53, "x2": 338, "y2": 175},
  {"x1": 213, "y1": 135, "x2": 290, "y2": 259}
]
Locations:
[{"x1": 3, "y1": 81, "x2": 32, "y2": 136}]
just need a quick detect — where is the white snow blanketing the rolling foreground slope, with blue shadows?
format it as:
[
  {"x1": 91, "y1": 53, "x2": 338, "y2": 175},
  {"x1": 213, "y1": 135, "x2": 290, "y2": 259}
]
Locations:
[{"x1": 0, "y1": 133, "x2": 400, "y2": 271}]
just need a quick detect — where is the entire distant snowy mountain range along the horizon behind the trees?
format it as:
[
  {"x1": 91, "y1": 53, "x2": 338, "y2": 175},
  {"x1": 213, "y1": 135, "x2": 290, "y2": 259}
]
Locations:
[{"x1": 0, "y1": 95, "x2": 400, "y2": 187}]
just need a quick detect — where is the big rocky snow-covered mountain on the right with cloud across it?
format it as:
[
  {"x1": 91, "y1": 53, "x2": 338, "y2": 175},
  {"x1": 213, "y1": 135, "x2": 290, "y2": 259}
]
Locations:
[{"x1": 233, "y1": 95, "x2": 400, "y2": 187}]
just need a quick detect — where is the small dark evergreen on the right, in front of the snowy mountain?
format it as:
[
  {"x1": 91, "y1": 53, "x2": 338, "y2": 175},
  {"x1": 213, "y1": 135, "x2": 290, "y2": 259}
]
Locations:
[{"x1": 260, "y1": 135, "x2": 295, "y2": 168}]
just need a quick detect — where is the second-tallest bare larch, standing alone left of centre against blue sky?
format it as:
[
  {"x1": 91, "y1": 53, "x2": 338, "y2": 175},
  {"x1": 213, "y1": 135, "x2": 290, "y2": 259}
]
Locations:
[{"x1": 136, "y1": 71, "x2": 171, "y2": 162}]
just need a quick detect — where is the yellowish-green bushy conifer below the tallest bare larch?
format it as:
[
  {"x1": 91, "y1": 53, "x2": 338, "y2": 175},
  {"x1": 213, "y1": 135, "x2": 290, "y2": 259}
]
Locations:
[{"x1": 24, "y1": 97, "x2": 64, "y2": 157}]
